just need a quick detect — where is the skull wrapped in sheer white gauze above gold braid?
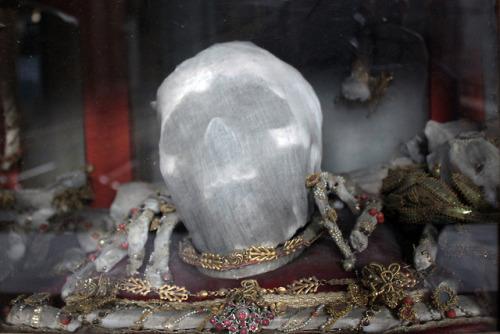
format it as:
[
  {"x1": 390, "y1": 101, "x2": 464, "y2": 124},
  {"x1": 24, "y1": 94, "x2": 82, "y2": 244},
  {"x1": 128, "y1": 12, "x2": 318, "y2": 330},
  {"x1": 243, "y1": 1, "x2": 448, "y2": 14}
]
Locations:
[{"x1": 157, "y1": 42, "x2": 322, "y2": 255}]
